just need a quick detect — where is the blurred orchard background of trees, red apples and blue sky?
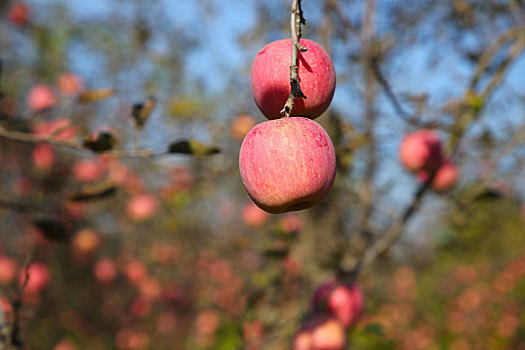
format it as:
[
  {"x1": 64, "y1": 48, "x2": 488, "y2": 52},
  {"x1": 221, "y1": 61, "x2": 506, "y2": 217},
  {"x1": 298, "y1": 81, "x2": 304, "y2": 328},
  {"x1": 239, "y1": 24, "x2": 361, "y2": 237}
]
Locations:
[{"x1": 0, "y1": 0, "x2": 525, "y2": 350}]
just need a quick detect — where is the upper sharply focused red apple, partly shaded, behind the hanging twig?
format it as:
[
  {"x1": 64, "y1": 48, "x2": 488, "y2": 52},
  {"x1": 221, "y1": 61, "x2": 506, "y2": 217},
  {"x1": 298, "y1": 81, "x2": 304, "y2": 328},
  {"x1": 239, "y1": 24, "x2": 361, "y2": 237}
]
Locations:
[{"x1": 251, "y1": 39, "x2": 335, "y2": 119}]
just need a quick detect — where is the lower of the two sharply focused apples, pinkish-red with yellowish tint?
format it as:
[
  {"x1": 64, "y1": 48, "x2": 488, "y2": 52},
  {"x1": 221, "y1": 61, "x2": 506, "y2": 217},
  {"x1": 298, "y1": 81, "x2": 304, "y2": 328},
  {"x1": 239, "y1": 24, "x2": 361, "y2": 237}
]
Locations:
[{"x1": 239, "y1": 117, "x2": 335, "y2": 214}]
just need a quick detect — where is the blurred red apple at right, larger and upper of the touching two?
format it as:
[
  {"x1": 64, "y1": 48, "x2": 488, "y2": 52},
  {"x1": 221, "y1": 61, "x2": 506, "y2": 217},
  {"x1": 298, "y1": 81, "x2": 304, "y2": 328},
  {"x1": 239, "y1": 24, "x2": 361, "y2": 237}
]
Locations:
[{"x1": 399, "y1": 130, "x2": 442, "y2": 171}]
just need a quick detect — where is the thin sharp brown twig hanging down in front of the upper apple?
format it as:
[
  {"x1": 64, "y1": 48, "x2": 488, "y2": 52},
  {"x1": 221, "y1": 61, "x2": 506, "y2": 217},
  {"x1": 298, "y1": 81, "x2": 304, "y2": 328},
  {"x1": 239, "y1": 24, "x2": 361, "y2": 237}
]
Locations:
[{"x1": 281, "y1": 0, "x2": 307, "y2": 118}]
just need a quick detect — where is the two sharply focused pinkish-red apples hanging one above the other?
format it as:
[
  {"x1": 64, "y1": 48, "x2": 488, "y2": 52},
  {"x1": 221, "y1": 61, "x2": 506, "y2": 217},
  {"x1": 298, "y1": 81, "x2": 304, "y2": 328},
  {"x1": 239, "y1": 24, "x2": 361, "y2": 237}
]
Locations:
[{"x1": 239, "y1": 39, "x2": 335, "y2": 214}]
